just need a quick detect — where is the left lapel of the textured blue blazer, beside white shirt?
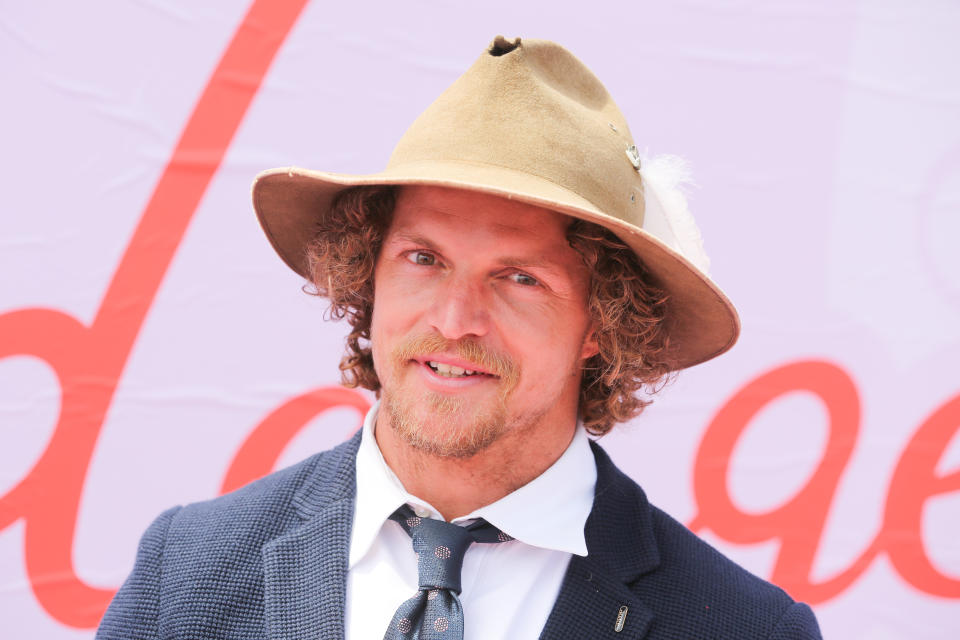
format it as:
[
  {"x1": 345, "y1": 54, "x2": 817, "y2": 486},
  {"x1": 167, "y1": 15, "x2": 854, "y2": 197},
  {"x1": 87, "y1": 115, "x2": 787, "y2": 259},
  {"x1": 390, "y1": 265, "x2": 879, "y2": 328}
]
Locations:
[{"x1": 262, "y1": 433, "x2": 360, "y2": 640}]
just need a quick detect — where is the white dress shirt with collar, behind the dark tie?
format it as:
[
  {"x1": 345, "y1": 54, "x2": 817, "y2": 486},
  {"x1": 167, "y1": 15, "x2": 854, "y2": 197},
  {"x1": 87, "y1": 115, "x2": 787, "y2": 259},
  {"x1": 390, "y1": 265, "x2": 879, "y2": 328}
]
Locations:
[{"x1": 345, "y1": 405, "x2": 597, "y2": 640}]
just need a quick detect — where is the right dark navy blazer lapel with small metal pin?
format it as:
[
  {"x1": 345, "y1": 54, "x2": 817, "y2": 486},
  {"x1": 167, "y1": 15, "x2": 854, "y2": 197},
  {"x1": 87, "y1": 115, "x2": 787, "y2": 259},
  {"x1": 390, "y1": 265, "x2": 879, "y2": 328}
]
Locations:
[{"x1": 540, "y1": 443, "x2": 660, "y2": 640}]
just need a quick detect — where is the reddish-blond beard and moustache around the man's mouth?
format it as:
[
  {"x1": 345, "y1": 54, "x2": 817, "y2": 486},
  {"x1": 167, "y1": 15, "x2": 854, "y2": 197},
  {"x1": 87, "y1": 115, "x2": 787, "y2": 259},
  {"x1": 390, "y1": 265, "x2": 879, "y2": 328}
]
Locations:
[{"x1": 382, "y1": 334, "x2": 520, "y2": 458}]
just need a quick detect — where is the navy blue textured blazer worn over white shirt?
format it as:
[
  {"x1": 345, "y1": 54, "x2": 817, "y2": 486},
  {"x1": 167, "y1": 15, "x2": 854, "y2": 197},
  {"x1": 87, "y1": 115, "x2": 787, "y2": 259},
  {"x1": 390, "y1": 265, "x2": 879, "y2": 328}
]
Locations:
[{"x1": 97, "y1": 434, "x2": 820, "y2": 640}]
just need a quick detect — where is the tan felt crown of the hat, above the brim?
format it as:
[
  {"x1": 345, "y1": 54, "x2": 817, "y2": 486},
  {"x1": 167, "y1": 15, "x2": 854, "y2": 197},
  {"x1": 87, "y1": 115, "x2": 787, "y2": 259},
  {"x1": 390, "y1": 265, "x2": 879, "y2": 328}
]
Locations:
[{"x1": 387, "y1": 36, "x2": 644, "y2": 227}]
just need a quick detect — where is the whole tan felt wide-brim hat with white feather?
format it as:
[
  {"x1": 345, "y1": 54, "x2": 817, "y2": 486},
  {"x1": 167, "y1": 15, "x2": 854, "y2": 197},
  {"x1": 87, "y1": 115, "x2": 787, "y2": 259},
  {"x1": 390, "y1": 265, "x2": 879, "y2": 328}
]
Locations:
[{"x1": 253, "y1": 36, "x2": 740, "y2": 369}]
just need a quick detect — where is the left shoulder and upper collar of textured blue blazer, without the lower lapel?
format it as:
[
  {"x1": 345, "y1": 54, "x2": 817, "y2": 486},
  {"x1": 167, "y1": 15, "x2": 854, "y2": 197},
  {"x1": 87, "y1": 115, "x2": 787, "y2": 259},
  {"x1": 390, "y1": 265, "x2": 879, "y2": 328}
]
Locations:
[{"x1": 97, "y1": 435, "x2": 359, "y2": 640}]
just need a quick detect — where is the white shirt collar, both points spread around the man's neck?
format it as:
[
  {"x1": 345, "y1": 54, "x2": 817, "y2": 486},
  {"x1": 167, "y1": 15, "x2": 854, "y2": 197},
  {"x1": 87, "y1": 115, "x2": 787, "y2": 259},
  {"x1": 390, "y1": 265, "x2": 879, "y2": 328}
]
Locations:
[{"x1": 350, "y1": 402, "x2": 597, "y2": 567}]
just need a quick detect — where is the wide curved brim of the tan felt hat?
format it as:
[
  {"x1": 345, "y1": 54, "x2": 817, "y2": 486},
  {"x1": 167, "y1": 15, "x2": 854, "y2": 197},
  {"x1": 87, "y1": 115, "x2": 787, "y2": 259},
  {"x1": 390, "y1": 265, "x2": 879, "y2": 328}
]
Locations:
[{"x1": 252, "y1": 162, "x2": 740, "y2": 369}]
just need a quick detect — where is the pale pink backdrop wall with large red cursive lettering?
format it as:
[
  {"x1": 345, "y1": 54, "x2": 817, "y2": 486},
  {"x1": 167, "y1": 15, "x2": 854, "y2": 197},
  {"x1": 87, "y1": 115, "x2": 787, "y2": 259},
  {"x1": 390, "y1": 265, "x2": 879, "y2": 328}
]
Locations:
[{"x1": 0, "y1": 0, "x2": 960, "y2": 640}]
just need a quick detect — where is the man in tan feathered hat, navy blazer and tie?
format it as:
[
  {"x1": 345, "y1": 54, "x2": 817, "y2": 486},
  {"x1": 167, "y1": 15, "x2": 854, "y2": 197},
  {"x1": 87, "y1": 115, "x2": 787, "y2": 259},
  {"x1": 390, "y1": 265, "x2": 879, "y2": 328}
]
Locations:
[{"x1": 98, "y1": 37, "x2": 820, "y2": 640}]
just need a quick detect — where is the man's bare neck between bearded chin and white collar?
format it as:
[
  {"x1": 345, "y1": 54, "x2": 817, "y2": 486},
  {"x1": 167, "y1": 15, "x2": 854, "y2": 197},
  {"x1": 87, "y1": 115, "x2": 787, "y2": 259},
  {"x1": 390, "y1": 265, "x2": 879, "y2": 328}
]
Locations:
[{"x1": 375, "y1": 411, "x2": 576, "y2": 521}]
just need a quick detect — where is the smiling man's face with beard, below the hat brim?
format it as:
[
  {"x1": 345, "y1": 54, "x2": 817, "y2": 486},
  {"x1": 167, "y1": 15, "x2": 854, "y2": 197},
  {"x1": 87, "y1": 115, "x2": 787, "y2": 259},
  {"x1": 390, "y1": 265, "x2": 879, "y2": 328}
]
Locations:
[{"x1": 371, "y1": 182, "x2": 596, "y2": 457}]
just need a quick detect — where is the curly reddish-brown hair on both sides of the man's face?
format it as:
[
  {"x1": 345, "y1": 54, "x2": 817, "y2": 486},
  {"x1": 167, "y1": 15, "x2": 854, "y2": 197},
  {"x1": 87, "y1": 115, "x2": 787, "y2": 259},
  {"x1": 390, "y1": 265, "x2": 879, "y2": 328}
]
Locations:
[{"x1": 305, "y1": 186, "x2": 676, "y2": 436}]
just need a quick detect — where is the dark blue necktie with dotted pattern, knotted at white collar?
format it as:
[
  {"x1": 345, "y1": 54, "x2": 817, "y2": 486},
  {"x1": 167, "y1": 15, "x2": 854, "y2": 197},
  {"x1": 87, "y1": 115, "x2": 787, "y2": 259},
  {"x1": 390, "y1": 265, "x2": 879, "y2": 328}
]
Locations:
[{"x1": 383, "y1": 505, "x2": 513, "y2": 640}]
